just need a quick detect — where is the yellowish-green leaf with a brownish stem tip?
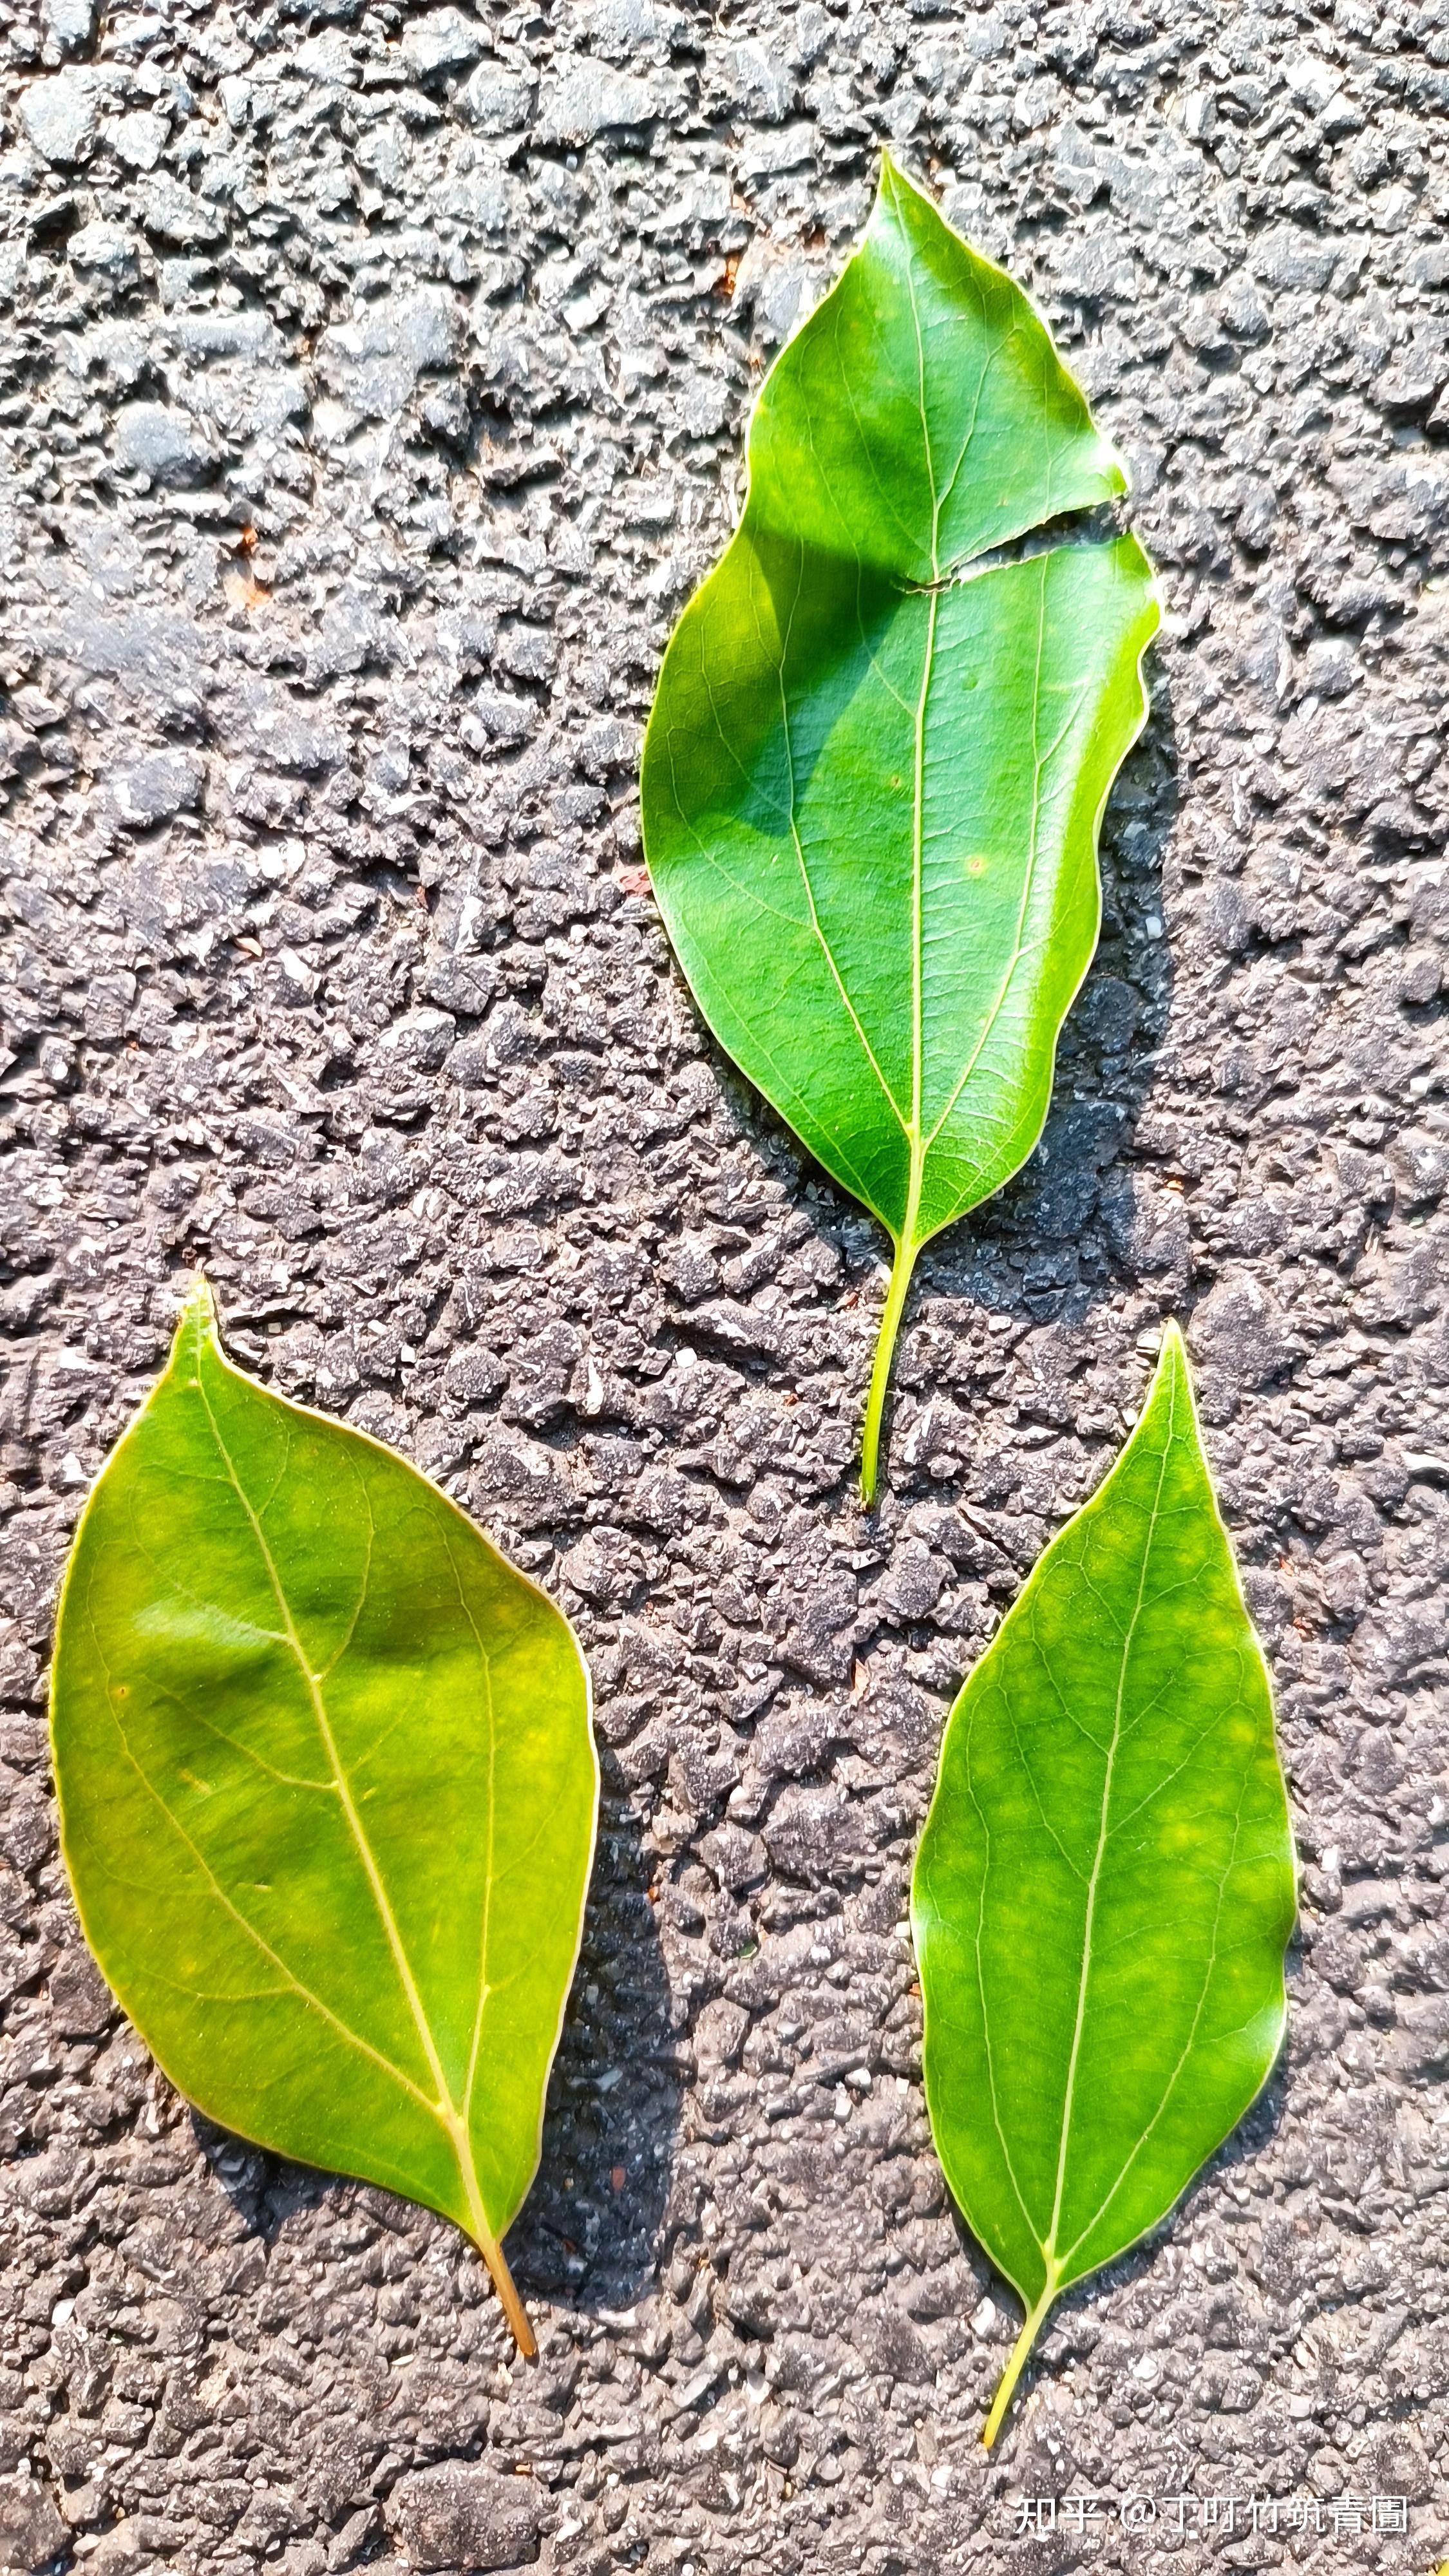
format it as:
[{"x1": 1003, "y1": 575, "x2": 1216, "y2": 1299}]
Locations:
[{"x1": 52, "y1": 1288, "x2": 598, "y2": 2352}]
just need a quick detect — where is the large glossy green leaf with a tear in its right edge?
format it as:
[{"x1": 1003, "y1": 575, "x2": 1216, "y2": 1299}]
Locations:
[{"x1": 642, "y1": 160, "x2": 1158, "y2": 1499}]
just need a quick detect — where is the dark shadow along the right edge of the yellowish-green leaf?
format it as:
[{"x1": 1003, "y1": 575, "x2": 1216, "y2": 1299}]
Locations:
[{"x1": 508, "y1": 1744, "x2": 683, "y2": 2313}]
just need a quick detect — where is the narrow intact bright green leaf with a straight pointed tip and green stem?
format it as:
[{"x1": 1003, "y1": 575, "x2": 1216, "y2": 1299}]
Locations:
[{"x1": 913, "y1": 1327, "x2": 1294, "y2": 2445}]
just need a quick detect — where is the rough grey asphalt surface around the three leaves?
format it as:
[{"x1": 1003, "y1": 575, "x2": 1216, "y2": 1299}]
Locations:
[{"x1": 0, "y1": 0, "x2": 1449, "y2": 2576}]
